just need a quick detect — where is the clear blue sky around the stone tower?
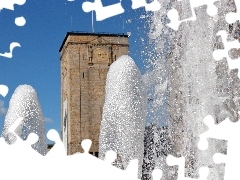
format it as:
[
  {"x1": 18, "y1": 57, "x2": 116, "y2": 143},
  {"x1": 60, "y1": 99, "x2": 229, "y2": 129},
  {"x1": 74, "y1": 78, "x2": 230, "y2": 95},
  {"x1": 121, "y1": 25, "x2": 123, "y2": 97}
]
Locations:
[{"x1": 0, "y1": 0, "x2": 154, "y2": 139}]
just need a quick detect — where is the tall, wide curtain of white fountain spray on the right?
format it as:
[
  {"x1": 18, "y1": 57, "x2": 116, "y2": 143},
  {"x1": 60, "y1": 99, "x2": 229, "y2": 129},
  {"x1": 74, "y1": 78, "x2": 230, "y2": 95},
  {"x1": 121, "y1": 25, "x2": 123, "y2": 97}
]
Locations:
[{"x1": 144, "y1": 0, "x2": 240, "y2": 179}]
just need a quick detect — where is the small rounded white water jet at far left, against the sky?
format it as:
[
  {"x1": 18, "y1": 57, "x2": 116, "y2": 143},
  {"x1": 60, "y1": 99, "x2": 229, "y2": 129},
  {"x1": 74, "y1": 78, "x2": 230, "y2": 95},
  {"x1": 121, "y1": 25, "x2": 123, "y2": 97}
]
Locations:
[{"x1": 2, "y1": 85, "x2": 47, "y2": 155}]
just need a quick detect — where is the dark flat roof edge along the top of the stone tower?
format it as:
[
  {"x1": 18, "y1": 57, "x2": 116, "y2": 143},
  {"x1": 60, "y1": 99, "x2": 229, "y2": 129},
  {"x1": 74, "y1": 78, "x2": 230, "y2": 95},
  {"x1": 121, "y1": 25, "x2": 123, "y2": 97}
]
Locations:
[{"x1": 59, "y1": 31, "x2": 129, "y2": 52}]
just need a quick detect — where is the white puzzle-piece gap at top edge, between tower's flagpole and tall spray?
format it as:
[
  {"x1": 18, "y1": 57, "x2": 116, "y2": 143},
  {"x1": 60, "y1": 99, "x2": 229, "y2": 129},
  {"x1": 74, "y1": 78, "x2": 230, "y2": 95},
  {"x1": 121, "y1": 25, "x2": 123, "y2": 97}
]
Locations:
[{"x1": 132, "y1": 0, "x2": 161, "y2": 11}]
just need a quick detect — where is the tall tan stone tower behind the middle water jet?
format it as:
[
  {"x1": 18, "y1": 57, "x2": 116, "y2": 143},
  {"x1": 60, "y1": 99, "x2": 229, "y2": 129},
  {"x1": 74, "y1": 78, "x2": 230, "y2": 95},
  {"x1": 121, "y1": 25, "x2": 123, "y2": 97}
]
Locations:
[{"x1": 59, "y1": 32, "x2": 129, "y2": 156}]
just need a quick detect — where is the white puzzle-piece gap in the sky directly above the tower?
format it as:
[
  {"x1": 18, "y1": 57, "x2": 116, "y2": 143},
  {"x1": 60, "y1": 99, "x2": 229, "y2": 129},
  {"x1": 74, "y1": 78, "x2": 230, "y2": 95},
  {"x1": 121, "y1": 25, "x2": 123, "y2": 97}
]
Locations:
[{"x1": 82, "y1": 0, "x2": 124, "y2": 21}]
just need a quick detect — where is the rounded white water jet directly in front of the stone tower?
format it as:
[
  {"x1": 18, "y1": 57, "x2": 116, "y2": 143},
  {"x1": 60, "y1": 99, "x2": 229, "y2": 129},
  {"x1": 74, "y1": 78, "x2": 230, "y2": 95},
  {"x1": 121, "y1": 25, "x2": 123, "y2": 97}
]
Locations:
[{"x1": 99, "y1": 55, "x2": 147, "y2": 178}]
